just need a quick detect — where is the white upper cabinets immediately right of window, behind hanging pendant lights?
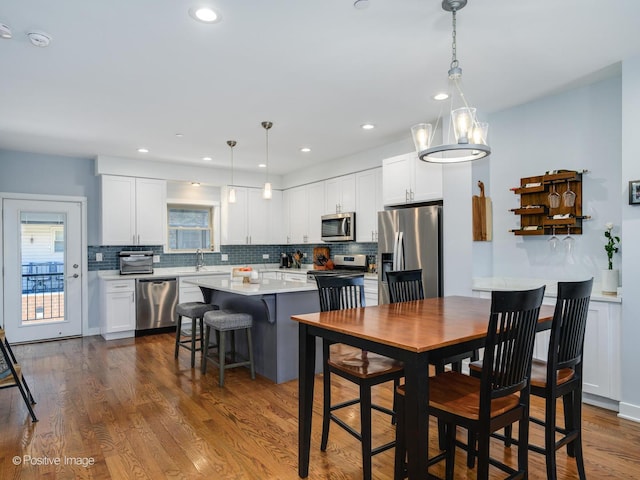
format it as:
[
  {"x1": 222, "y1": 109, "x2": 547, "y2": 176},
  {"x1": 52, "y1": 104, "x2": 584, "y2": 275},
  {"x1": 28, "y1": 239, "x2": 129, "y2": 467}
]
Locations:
[{"x1": 220, "y1": 187, "x2": 282, "y2": 245}]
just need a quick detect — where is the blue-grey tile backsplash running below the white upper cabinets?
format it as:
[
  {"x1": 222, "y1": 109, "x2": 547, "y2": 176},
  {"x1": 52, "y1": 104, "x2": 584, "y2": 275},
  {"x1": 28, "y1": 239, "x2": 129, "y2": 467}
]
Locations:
[{"x1": 88, "y1": 242, "x2": 378, "y2": 271}]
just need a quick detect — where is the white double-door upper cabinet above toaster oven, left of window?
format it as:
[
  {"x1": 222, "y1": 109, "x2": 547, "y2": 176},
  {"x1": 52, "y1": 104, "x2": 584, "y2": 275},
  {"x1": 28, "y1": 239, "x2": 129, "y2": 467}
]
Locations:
[{"x1": 100, "y1": 175, "x2": 167, "y2": 245}]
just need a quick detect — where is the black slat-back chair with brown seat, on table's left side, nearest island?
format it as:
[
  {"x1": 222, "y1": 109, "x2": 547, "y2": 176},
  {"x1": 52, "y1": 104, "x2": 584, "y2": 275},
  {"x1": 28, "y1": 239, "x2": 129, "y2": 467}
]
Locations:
[{"x1": 316, "y1": 275, "x2": 404, "y2": 480}]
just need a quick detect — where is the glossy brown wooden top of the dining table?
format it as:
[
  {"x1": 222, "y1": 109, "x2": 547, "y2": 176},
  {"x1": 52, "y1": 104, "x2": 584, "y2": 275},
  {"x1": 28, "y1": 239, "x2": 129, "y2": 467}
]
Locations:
[{"x1": 291, "y1": 296, "x2": 553, "y2": 353}]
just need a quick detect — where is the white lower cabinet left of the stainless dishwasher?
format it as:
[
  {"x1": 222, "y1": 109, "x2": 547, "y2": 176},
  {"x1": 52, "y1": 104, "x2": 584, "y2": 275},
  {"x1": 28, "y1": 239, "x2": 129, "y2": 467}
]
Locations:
[{"x1": 100, "y1": 280, "x2": 136, "y2": 340}]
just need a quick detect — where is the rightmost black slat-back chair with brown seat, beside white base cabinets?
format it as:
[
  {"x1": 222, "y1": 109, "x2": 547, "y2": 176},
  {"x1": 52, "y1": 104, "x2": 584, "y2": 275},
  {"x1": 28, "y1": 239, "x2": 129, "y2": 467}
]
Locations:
[{"x1": 471, "y1": 278, "x2": 593, "y2": 480}]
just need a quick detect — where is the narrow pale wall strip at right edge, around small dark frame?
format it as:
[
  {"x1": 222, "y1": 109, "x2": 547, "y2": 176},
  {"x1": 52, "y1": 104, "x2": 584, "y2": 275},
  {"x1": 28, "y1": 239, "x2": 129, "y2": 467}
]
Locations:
[{"x1": 617, "y1": 56, "x2": 640, "y2": 420}]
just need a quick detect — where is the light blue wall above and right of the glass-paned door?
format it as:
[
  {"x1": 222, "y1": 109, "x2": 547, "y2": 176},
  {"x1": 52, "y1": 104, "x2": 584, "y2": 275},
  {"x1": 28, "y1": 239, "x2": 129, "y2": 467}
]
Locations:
[{"x1": 0, "y1": 149, "x2": 100, "y2": 245}]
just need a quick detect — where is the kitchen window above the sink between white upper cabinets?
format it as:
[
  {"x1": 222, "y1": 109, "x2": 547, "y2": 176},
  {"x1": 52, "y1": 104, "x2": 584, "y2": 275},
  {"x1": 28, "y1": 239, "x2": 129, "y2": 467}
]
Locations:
[{"x1": 167, "y1": 204, "x2": 215, "y2": 252}]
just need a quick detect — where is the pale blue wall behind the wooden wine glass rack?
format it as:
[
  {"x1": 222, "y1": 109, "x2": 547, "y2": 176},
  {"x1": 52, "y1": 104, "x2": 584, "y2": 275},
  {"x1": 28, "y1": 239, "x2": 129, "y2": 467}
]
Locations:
[{"x1": 482, "y1": 76, "x2": 621, "y2": 283}]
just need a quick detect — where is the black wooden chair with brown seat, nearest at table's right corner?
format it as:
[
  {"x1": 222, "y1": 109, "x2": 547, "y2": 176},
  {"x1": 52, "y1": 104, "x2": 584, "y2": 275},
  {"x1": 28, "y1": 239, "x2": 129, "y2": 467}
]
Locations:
[{"x1": 395, "y1": 287, "x2": 544, "y2": 480}]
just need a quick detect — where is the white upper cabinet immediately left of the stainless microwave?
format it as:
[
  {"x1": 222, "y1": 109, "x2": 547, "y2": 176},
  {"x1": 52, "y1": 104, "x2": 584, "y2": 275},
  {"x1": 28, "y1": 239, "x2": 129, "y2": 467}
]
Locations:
[{"x1": 283, "y1": 182, "x2": 325, "y2": 244}]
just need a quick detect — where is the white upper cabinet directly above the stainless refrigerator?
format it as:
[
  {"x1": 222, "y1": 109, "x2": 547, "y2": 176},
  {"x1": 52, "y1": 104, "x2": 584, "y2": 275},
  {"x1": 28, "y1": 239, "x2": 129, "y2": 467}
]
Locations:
[{"x1": 382, "y1": 153, "x2": 442, "y2": 205}]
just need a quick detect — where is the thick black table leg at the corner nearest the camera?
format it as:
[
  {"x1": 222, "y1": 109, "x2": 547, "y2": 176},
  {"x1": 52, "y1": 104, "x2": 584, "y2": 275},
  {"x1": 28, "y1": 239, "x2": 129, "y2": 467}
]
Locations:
[{"x1": 404, "y1": 353, "x2": 429, "y2": 480}]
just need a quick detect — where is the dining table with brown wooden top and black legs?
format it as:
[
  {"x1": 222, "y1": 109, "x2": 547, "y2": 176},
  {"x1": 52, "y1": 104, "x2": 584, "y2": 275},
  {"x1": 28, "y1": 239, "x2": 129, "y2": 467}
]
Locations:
[{"x1": 291, "y1": 296, "x2": 553, "y2": 480}]
